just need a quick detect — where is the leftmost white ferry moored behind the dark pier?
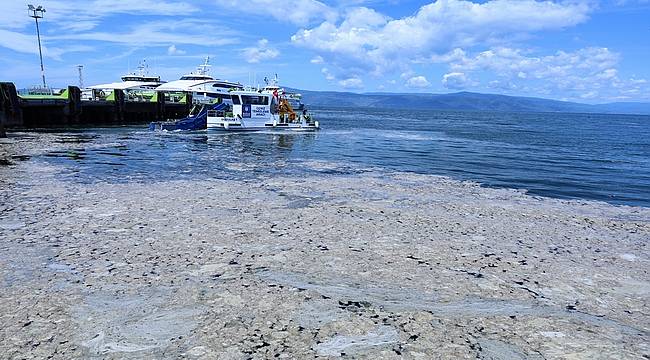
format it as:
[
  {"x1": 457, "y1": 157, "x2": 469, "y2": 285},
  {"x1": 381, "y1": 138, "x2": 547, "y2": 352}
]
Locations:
[{"x1": 81, "y1": 60, "x2": 165, "y2": 101}]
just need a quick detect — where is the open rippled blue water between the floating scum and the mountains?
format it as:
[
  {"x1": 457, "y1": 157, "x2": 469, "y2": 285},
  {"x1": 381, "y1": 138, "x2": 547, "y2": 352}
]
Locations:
[{"x1": 39, "y1": 109, "x2": 650, "y2": 207}]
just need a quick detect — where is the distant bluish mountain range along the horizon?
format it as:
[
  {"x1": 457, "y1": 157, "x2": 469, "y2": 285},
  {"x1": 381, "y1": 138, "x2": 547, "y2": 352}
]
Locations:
[{"x1": 295, "y1": 89, "x2": 650, "y2": 115}]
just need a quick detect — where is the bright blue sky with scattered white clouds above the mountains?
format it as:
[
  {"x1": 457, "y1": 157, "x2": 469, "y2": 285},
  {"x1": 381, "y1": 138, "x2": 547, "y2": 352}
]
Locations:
[{"x1": 0, "y1": 0, "x2": 650, "y2": 103}]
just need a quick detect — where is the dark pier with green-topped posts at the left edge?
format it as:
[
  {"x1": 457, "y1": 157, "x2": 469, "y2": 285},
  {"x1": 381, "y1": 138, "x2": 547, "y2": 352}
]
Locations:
[{"x1": 0, "y1": 82, "x2": 192, "y2": 129}]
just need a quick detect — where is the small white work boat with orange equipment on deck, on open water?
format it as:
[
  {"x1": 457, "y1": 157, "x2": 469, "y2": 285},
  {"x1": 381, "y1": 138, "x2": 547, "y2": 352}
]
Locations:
[{"x1": 207, "y1": 89, "x2": 320, "y2": 131}]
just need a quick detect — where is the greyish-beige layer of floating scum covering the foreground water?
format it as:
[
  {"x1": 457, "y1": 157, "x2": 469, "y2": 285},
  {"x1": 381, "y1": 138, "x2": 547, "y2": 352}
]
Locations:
[{"x1": 0, "y1": 134, "x2": 650, "y2": 359}]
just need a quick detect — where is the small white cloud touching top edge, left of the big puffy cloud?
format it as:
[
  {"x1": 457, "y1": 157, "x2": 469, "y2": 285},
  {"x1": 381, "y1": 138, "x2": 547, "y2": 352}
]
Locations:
[{"x1": 215, "y1": 0, "x2": 337, "y2": 25}]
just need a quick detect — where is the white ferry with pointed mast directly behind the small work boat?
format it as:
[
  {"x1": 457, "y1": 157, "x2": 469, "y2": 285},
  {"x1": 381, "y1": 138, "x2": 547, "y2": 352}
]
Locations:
[{"x1": 156, "y1": 57, "x2": 243, "y2": 103}]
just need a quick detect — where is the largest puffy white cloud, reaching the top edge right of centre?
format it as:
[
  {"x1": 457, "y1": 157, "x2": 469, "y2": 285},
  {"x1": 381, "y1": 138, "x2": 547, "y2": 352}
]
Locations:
[{"x1": 291, "y1": 0, "x2": 590, "y2": 77}]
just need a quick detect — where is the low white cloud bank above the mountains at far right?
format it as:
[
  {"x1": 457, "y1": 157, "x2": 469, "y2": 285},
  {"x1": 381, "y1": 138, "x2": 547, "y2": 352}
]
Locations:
[{"x1": 434, "y1": 47, "x2": 645, "y2": 99}]
